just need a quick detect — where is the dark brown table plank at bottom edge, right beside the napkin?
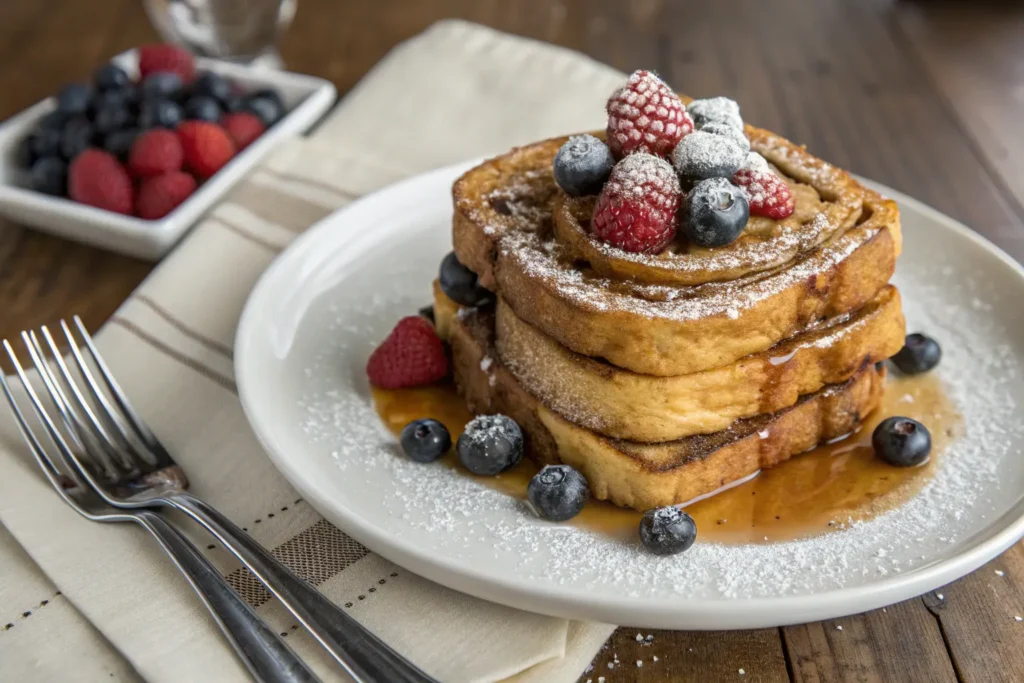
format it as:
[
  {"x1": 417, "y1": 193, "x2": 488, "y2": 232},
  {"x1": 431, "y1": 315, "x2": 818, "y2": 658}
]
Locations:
[{"x1": 580, "y1": 627, "x2": 790, "y2": 683}]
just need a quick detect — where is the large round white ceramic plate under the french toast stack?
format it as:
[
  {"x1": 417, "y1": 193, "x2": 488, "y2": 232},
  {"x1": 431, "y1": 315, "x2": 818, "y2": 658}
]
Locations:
[{"x1": 236, "y1": 165, "x2": 1024, "y2": 629}]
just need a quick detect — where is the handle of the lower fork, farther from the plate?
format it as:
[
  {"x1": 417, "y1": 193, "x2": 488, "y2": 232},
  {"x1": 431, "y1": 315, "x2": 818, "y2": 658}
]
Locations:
[{"x1": 136, "y1": 510, "x2": 319, "y2": 683}]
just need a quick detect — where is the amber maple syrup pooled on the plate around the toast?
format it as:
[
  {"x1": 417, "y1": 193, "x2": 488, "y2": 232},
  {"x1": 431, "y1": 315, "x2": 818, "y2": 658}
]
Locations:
[{"x1": 373, "y1": 373, "x2": 962, "y2": 544}]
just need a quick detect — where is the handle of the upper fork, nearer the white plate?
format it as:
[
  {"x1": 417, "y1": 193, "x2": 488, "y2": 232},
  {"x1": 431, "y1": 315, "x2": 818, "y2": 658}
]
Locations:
[{"x1": 163, "y1": 492, "x2": 437, "y2": 683}]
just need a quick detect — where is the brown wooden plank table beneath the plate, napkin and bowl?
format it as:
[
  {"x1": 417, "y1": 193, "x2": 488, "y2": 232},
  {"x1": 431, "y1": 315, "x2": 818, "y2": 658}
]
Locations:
[{"x1": 0, "y1": 0, "x2": 1024, "y2": 683}]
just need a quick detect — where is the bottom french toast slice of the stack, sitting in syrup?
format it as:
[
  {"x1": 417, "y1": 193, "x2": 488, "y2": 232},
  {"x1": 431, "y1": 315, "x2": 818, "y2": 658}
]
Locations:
[{"x1": 448, "y1": 307, "x2": 886, "y2": 510}]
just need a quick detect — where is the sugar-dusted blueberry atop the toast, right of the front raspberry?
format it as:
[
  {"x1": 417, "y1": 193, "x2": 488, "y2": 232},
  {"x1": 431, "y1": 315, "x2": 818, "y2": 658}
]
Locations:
[{"x1": 681, "y1": 179, "x2": 751, "y2": 247}]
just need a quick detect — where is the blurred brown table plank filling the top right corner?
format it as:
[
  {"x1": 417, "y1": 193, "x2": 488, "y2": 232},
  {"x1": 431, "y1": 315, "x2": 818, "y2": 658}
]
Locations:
[{"x1": 893, "y1": 2, "x2": 1024, "y2": 224}]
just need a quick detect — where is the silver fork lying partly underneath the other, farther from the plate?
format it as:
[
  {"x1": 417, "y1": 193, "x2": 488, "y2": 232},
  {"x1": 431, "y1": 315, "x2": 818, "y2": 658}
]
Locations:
[{"x1": 0, "y1": 348, "x2": 318, "y2": 683}]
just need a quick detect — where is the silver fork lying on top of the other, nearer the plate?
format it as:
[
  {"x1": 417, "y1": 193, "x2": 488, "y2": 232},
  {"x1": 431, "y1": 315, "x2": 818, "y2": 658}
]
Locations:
[{"x1": 16, "y1": 315, "x2": 437, "y2": 683}]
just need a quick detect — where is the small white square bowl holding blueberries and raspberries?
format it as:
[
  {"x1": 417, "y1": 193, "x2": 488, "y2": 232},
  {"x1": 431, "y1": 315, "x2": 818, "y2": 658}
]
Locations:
[{"x1": 0, "y1": 50, "x2": 337, "y2": 260}]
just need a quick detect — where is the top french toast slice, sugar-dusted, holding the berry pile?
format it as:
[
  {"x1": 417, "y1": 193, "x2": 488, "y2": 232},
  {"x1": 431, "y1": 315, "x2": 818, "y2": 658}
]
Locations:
[{"x1": 453, "y1": 137, "x2": 901, "y2": 376}]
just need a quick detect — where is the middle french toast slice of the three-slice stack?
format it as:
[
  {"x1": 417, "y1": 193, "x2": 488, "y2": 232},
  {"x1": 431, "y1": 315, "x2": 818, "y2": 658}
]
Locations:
[{"x1": 491, "y1": 286, "x2": 904, "y2": 442}]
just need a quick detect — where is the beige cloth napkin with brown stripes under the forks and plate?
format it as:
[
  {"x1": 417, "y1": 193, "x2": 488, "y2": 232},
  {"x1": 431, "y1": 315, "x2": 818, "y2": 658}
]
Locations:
[{"x1": 0, "y1": 22, "x2": 622, "y2": 683}]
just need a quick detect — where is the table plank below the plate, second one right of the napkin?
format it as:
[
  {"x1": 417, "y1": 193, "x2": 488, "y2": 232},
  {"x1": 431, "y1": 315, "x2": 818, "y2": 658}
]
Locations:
[{"x1": 782, "y1": 599, "x2": 956, "y2": 683}]
